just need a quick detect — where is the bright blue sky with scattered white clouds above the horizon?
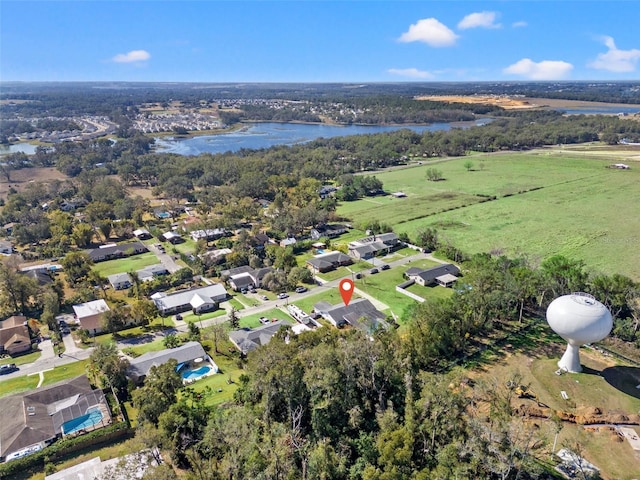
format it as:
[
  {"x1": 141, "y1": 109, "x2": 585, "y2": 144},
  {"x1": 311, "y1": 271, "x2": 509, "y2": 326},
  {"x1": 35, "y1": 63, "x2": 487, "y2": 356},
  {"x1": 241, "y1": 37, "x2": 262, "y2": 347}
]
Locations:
[{"x1": 0, "y1": 0, "x2": 640, "y2": 82}]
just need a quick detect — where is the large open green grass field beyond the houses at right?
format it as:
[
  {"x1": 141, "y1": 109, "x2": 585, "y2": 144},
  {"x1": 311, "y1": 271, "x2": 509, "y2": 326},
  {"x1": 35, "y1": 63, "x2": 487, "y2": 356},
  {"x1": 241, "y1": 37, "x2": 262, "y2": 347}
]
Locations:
[{"x1": 338, "y1": 147, "x2": 640, "y2": 279}]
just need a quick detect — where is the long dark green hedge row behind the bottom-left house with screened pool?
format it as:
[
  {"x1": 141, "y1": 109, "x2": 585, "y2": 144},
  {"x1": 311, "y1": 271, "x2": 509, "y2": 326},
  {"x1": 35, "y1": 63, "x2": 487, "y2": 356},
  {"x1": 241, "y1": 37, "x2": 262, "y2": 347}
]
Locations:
[{"x1": 0, "y1": 422, "x2": 132, "y2": 479}]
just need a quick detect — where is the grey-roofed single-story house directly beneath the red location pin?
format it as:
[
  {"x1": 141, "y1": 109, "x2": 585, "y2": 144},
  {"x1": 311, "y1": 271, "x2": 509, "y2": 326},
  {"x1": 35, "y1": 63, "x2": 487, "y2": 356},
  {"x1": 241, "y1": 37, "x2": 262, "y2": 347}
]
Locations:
[{"x1": 313, "y1": 298, "x2": 388, "y2": 333}]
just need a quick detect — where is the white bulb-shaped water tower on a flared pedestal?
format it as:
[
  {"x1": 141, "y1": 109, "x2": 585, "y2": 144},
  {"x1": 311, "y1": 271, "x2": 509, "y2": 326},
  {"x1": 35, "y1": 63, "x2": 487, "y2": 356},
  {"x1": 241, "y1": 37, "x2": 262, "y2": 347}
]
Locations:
[{"x1": 547, "y1": 293, "x2": 613, "y2": 373}]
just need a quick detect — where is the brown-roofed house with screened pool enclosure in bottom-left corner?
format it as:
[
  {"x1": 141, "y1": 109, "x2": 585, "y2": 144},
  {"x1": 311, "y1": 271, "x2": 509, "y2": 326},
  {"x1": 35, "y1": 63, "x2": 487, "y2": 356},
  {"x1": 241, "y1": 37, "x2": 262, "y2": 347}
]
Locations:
[{"x1": 0, "y1": 375, "x2": 111, "y2": 461}]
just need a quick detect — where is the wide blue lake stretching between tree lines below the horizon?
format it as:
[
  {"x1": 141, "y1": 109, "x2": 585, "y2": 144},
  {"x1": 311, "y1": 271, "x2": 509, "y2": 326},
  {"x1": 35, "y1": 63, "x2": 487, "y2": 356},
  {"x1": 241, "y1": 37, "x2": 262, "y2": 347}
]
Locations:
[{"x1": 155, "y1": 119, "x2": 490, "y2": 155}]
